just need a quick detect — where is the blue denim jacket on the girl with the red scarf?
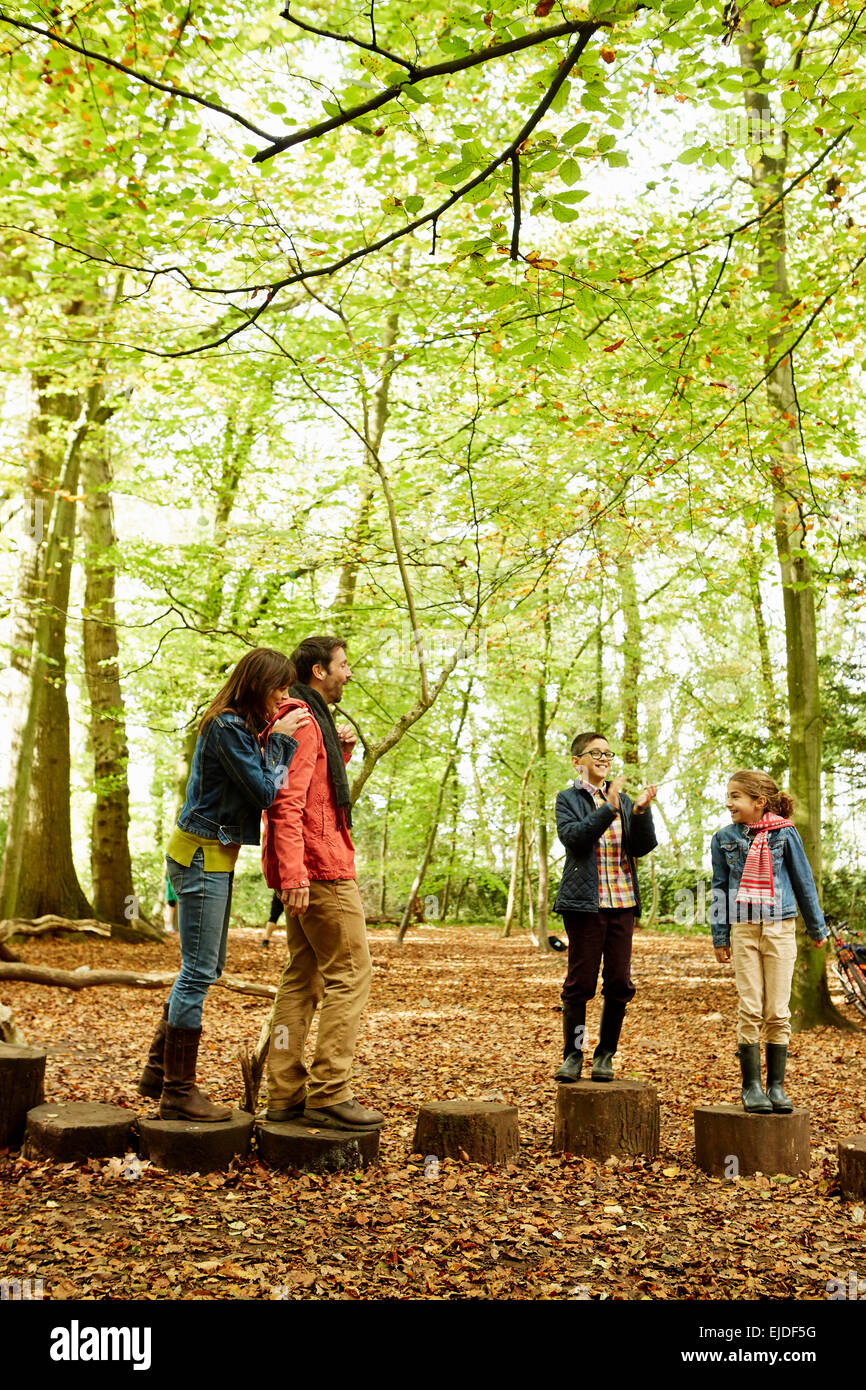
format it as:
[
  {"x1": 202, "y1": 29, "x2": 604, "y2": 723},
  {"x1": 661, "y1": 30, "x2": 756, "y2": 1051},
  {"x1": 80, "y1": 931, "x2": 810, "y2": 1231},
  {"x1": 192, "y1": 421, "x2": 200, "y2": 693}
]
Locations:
[{"x1": 710, "y1": 824, "x2": 830, "y2": 947}]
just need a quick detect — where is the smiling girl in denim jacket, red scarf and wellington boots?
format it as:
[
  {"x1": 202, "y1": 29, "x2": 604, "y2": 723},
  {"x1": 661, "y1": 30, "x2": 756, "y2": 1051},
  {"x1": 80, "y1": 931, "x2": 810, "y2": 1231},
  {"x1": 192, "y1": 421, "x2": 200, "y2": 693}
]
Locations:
[{"x1": 710, "y1": 769, "x2": 828, "y2": 1115}]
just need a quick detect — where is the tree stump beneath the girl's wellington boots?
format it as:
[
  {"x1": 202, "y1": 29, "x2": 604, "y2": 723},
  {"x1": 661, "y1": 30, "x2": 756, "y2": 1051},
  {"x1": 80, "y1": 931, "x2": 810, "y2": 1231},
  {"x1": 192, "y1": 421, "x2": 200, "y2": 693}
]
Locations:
[{"x1": 695, "y1": 1105, "x2": 809, "y2": 1177}]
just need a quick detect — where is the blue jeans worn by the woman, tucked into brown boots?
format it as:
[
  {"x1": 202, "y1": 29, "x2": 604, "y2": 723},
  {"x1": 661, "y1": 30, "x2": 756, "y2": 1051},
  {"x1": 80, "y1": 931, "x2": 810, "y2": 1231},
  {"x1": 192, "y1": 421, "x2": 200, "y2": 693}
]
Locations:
[{"x1": 165, "y1": 849, "x2": 235, "y2": 1029}]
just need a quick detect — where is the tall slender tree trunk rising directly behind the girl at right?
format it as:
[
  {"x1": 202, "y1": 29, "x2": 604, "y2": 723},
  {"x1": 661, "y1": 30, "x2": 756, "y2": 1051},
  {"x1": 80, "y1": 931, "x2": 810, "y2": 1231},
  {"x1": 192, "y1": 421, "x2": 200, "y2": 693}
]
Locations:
[{"x1": 740, "y1": 19, "x2": 841, "y2": 1031}]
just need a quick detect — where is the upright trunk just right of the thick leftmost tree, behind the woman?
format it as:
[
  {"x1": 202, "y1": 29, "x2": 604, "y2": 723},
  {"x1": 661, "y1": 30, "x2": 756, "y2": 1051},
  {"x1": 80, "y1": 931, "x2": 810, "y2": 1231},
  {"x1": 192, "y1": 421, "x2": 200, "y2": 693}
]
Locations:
[{"x1": 83, "y1": 446, "x2": 134, "y2": 923}]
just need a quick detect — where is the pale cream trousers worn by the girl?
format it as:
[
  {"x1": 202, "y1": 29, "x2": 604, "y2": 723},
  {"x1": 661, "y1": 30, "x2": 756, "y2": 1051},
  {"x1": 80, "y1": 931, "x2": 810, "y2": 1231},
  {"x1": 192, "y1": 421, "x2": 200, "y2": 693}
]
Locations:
[{"x1": 731, "y1": 917, "x2": 796, "y2": 1044}]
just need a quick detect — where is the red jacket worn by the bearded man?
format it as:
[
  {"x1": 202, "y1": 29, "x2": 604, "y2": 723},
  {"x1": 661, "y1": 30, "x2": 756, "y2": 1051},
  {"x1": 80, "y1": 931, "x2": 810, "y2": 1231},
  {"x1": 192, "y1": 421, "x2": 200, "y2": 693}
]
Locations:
[{"x1": 261, "y1": 699, "x2": 354, "y2": 892}]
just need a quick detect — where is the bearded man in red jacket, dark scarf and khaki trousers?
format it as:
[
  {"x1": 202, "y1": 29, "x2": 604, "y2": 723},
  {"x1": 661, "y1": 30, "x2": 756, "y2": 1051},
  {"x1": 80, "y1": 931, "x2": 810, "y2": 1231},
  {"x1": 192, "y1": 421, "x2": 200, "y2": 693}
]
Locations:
[{"x1": 261, "y1": 637, "x2": 384, "y2": 1130}]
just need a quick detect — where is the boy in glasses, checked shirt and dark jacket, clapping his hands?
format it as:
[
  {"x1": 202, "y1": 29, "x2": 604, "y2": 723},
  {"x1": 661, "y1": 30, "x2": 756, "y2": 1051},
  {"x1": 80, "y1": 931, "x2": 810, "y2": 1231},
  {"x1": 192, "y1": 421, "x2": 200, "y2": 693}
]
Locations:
[{"x1": 553, "y1": 733, "x2": 656, "y2": 1081}]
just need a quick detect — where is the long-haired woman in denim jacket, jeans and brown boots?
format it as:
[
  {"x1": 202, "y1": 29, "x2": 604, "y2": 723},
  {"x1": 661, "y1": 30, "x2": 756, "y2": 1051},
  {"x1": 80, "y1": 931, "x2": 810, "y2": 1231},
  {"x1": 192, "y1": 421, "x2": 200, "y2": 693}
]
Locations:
[{"x1": 139, "y1": 646, "x2": 310, "y2": 1120}]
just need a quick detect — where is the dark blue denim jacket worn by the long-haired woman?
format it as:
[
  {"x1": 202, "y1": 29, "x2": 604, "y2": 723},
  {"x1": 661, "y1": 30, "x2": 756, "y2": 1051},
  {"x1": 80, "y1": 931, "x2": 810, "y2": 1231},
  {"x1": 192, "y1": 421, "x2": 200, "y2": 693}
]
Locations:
[{"x1": 178, "y1": 712, "x2": 297, "y2": 845}]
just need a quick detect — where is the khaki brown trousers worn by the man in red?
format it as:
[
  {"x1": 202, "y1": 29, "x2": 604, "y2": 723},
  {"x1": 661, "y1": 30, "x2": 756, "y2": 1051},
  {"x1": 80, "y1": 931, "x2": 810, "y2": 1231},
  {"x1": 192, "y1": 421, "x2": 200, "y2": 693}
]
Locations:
[{"x1": 268, "y1": 878, "x2": 373, "y2": 1109}]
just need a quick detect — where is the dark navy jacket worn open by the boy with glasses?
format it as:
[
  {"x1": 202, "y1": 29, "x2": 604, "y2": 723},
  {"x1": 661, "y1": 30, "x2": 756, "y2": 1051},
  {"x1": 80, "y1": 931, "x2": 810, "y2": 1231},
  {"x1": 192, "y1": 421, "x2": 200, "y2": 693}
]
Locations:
[{"x1": 553, "y1": 783, "x2": 656, "y2": 919}]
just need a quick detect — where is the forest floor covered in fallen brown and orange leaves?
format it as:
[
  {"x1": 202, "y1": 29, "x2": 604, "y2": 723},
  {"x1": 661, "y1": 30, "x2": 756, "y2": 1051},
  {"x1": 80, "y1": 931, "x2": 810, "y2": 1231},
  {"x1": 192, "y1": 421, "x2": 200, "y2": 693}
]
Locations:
[{"x1": 0, "y1": 927, "x2": 866, "y2": 1300}]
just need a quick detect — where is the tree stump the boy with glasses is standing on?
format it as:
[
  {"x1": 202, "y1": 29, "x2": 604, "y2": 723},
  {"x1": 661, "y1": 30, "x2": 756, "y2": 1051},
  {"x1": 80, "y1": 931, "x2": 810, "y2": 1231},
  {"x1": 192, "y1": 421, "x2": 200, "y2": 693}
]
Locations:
[{"x1": 553, "y1": 1080, "x2": 659, "y2": 1161}]
